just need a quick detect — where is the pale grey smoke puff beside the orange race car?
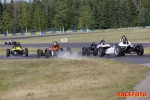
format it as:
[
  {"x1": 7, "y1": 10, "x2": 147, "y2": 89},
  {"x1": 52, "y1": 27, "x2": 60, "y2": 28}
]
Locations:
[{"x1": 57, "y1": 52, "x2": 85, "y2": 59}]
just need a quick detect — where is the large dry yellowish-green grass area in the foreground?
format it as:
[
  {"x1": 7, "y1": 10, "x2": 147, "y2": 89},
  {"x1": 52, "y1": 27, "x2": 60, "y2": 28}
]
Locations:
[{"x1": 0, "y1": 59, "x2": 150, "y2": 100}]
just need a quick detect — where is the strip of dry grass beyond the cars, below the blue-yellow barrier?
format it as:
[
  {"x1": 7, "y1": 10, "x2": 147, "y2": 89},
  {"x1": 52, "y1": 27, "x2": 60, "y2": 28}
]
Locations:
[{"x1": 0, "y1": 29, "x2": 150, "y2": 44}]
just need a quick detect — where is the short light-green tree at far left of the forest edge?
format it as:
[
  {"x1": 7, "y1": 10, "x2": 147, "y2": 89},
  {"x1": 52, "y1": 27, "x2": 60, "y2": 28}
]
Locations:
[{"x1": 2, "y1": 11, "x2": 12, "y2": 32}]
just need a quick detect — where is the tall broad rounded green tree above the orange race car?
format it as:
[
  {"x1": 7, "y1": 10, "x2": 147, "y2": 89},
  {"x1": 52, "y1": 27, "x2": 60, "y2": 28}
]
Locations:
[{"x1": 54, "y1": 1, "x2": 70, "y2": 29}]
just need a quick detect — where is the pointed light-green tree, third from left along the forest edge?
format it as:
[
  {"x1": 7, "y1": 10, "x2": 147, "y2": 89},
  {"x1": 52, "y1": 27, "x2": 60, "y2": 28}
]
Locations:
[{"x1": 33, "y1": 4, "x2": 47, "y2": 31}]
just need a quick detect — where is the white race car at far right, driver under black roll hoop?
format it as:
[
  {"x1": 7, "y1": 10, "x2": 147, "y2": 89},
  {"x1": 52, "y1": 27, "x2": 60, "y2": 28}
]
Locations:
[{"x1": 97, "y1": 35, "x2": 144, "y2": 57}]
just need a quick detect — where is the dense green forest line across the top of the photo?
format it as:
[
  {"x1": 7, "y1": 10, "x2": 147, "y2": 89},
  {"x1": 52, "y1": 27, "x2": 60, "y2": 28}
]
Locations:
[{"x1": 0, "y1": 0, "x2": 150, "y2": 32}]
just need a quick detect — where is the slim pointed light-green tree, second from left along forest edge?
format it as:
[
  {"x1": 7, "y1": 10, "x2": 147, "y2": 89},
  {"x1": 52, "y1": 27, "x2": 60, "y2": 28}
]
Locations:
[{"x1": 20, "y1": 4, "x2": 32, "y2": 30}]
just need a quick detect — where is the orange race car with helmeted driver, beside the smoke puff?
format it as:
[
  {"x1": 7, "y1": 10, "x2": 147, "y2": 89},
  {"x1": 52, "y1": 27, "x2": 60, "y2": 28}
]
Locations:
[{"x1": 37, "y1": 41, "x2": 71, "y2": 58}]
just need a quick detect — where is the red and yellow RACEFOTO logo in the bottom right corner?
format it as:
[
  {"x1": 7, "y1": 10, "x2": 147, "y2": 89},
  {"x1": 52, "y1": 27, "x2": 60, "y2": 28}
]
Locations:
[{"x1": 116, "y1": 92, "x2": 147, "y2": 98}]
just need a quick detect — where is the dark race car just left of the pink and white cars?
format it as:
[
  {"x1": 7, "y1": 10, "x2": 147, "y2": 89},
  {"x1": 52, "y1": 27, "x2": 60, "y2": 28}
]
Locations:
[{"x1": 82, "y1": 42, "x2": 97, "y2": 56}]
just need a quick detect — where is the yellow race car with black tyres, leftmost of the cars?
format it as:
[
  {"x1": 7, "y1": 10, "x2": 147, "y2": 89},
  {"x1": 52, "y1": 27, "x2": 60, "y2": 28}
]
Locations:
[{"x1": 6, "y1": 42, "x2": 28, "y2": 57}]
